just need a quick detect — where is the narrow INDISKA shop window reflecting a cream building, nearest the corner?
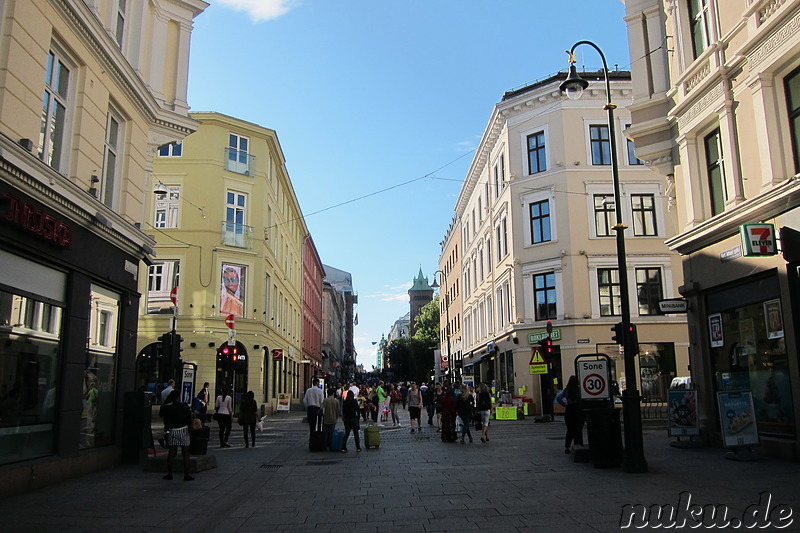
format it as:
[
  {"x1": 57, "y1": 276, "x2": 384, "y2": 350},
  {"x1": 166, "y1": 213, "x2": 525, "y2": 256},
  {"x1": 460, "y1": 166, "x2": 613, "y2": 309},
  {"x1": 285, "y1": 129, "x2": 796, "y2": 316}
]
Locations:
[{"x1": 80, "y1": 285, "x2": 119, "y2": 448}]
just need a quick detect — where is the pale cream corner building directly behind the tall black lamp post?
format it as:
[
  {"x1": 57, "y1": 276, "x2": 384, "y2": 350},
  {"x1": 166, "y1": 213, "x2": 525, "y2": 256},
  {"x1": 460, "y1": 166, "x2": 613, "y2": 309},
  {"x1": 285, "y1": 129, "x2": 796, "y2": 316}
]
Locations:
[{"x1": 456, "y1": 71, "x2": 688, "y2": 412}]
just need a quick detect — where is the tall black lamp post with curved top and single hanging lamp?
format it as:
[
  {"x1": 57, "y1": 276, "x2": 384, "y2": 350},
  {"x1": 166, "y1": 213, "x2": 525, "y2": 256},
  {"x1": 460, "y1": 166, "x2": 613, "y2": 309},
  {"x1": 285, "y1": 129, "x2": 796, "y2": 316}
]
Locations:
[{"x1": 559, "y1": 41, "x2": 647, "y2": 473}]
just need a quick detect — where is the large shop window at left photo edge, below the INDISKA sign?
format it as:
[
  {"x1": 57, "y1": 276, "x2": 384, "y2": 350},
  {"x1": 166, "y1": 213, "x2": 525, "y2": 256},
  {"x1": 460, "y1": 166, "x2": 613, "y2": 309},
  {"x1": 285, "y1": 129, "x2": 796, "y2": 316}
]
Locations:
[{"x1": 0, "y1": 290, "x2": 62, "y2": 464}]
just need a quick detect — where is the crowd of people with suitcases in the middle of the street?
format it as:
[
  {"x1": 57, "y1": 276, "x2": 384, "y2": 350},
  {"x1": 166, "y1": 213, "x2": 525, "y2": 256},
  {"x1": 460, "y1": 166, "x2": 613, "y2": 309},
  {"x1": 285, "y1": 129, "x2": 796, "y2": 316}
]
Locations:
[{"x1": 303, "y1": 378, "x2": 492, "y2": 452}]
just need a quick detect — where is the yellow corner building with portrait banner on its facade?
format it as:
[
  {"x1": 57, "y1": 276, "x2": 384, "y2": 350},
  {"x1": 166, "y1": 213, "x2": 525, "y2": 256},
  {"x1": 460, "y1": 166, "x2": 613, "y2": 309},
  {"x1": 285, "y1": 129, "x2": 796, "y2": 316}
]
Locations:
[{"x1": 137, "y1": 113, "x2": 308, "y2": 411}]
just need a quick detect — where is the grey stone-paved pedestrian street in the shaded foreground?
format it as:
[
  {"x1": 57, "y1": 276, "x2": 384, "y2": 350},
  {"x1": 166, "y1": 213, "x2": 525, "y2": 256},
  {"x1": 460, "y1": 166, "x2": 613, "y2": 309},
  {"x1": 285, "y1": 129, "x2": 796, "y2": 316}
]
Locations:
[{"x1": 0, "y1": 412, "x2": 800, "y2": 533}]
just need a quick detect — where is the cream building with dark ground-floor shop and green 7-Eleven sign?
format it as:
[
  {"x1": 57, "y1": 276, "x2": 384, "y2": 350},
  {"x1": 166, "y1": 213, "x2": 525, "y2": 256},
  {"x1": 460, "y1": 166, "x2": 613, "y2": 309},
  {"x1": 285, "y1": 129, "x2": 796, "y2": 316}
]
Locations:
[{"x1": 625, "y1": 0, "x2": 800, "y2": 459}]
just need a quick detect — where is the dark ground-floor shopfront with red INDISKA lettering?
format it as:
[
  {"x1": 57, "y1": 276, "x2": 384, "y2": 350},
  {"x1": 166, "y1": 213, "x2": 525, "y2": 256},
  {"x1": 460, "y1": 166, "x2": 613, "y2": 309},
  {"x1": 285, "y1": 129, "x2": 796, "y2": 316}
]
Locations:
[{"x1": 0, "y1": 157, "x2": 147, "y2": 497}]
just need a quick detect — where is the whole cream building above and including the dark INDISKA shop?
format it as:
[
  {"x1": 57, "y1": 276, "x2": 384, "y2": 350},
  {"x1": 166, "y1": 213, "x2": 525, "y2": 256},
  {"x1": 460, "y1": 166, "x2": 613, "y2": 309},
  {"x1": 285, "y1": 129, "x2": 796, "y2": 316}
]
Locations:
[{"x1": 0, "y1": 0, "x2": 208, "y2": 497}]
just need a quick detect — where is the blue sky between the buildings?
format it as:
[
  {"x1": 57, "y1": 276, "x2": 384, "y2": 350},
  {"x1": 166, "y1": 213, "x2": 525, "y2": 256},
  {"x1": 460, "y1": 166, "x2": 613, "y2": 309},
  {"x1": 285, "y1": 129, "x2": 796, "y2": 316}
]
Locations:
[{"x1": 188, "y1": 0, "x2": 630, "y2": 371}]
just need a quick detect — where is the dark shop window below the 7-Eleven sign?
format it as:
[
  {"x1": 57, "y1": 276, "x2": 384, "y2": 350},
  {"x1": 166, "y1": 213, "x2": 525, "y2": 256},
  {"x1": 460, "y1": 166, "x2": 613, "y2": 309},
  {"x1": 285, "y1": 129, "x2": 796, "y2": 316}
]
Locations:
[{"x1": 708, "y1": 277, "x2": 795, "y2": 437}]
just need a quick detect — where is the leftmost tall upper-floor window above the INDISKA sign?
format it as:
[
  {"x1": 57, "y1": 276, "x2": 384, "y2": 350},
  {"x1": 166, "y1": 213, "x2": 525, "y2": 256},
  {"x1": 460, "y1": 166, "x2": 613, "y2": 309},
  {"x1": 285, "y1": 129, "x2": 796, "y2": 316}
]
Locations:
[{"x1": 38, "y1": 50, "x2": 71, "y2": 174}]
